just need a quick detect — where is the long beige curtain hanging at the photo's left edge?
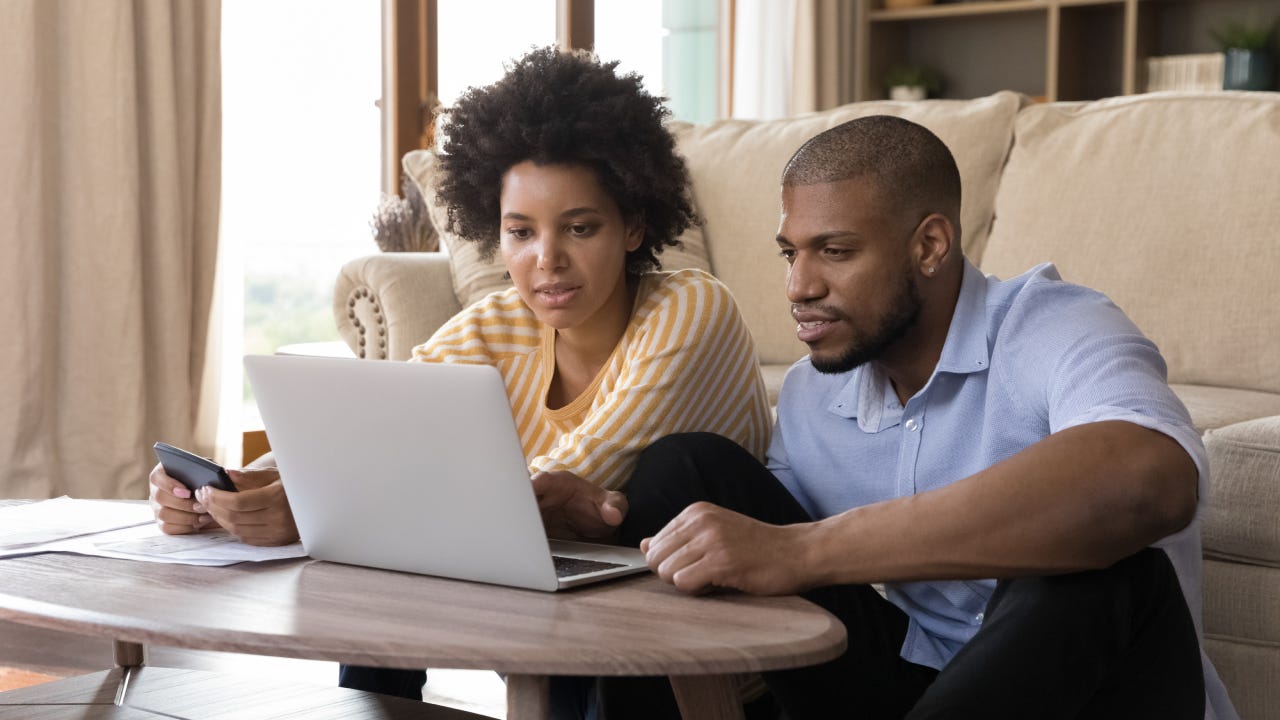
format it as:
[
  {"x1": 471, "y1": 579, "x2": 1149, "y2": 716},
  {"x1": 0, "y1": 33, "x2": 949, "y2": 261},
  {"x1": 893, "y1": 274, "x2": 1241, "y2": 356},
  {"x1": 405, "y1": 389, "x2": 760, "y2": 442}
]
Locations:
[{"x1": 0, "y1": 0, "x2": 221, "y2": 497}]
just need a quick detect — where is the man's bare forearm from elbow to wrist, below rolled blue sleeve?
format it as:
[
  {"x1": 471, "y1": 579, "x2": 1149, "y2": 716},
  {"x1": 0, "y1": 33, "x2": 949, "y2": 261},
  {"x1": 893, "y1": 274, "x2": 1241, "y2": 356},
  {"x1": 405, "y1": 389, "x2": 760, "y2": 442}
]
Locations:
[{"x1": 803, "y1": 421, "x2": 1197, "y2": 585}]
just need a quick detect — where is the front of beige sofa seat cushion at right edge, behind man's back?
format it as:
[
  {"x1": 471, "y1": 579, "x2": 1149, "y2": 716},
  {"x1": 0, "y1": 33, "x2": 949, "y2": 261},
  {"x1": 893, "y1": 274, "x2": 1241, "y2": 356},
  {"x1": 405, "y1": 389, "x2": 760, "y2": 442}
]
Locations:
[{"x1": 1201, "y1": 415, "x2": 1280, "y2": 566}]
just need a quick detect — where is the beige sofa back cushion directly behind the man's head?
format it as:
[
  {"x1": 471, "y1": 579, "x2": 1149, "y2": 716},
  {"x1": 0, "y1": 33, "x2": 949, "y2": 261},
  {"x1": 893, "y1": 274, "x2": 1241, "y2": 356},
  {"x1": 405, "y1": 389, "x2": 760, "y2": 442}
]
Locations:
[{"x1": 672, "y1": 92, "x2": 1024, "y2": 365}]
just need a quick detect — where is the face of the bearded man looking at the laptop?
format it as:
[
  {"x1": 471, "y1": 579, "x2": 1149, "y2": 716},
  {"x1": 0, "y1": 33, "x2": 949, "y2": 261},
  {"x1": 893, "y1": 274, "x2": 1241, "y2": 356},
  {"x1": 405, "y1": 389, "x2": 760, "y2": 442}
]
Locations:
[{"x1": 777, "y1": 178, "x2": 920, "y2": 373}]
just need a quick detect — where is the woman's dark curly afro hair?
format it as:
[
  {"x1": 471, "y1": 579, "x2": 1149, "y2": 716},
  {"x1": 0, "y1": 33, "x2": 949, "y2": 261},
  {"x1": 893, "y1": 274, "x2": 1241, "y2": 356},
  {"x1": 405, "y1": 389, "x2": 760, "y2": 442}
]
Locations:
[{"x1": 436, "y1": 47, "x2": 700, "y2": 275}]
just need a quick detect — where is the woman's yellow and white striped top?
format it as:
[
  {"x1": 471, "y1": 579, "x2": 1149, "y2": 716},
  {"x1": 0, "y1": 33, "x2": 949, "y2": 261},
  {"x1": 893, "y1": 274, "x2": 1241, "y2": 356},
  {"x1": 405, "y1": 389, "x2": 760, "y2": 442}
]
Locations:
[{"x1": 412, "y1": 270, "x2": 772, "y2": 489}]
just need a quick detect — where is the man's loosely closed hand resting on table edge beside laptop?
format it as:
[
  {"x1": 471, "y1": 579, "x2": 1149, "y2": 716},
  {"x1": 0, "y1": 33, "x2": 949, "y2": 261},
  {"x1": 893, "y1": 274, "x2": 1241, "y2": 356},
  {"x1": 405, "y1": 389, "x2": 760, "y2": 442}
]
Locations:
[{"x1": 640, "y1": 502, "x2": 814, "y2": 594}]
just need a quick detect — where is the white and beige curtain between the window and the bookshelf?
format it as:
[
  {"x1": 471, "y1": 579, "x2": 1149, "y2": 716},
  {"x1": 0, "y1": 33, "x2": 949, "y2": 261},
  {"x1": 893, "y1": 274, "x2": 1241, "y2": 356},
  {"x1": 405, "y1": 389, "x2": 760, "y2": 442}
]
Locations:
[{"x1": 732, "y1": 0, "x2": 855, "y2": 120}]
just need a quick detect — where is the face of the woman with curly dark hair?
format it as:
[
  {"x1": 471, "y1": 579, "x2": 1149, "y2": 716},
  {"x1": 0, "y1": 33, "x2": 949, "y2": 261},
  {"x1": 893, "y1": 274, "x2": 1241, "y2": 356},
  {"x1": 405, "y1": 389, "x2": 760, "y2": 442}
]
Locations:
[{"x1": 499, "y1": 160, "x2": 644, "y2": 331}]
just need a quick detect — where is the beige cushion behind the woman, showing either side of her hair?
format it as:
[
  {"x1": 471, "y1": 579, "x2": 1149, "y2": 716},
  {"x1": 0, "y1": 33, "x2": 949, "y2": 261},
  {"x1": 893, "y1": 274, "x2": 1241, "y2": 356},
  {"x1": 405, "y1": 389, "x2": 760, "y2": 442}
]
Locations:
[{"x1": 401, "y1": 150, "x2": 710, "y2": 306}]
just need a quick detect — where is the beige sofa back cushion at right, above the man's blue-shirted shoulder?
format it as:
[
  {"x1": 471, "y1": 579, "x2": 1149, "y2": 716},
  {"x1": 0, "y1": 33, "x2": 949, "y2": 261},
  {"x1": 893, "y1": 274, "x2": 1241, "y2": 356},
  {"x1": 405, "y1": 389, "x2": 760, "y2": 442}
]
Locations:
[{"x1": 982, "y1": 92, "x2": 1280, "y2": 392}]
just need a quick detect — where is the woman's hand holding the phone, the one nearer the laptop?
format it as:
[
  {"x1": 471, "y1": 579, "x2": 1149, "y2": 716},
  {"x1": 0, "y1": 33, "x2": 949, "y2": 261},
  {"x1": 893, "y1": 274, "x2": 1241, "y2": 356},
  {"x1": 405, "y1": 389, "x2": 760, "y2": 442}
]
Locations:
[{"x1": 196, "y1": 468, "x2": 298, "y2": 546}]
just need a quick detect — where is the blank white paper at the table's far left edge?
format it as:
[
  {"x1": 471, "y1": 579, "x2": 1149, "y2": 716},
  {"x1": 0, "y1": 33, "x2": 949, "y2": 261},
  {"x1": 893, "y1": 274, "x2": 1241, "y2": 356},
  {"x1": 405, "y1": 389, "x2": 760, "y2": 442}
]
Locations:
[{"x1": 0, "y1": 496, "x2": 152, "y2": 551}]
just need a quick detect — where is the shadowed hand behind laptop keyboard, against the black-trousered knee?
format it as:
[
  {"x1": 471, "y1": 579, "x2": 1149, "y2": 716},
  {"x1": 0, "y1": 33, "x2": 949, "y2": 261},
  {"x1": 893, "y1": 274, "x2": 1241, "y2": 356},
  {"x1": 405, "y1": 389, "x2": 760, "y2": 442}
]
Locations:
[{"x1": 532, "y1": 470, "x2": 627, "y2": 541}]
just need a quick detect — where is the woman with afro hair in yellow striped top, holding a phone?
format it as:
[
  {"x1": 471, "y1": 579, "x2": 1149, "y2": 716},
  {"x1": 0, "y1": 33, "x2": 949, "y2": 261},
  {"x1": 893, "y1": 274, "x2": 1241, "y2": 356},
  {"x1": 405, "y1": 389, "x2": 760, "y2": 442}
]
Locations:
[{"x1": 151, "y1": 49, "x2": 771, "y2": 712}]
